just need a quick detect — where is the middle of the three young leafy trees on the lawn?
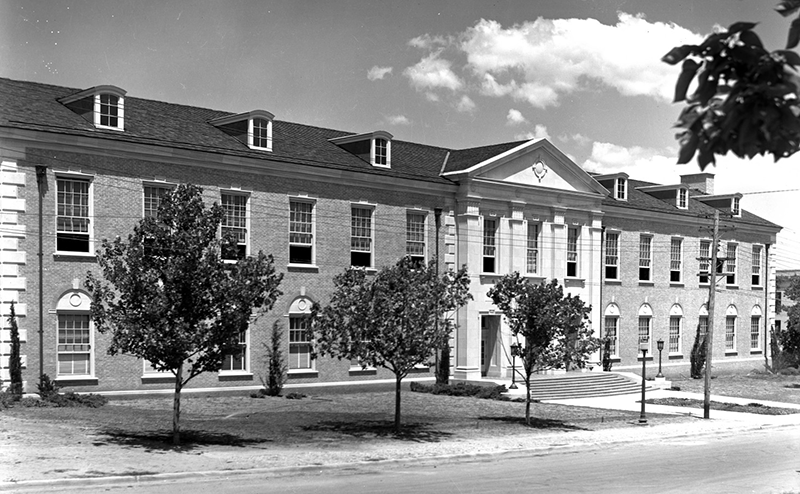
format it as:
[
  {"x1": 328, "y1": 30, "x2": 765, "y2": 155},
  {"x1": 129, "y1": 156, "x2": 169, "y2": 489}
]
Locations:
[{"x1": 309, "y1": 257, "x2": 472, "y2": 432}]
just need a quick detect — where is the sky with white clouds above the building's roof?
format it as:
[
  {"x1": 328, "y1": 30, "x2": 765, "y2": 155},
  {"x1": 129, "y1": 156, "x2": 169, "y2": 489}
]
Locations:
[{"x1": 0, "y1": 0, "x2": 800, "y2": 269}]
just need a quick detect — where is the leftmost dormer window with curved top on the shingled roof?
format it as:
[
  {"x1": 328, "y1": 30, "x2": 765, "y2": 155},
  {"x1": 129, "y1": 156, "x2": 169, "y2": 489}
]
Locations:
[{"x1": 59, "y1": 86, "x2": 126, "y2": 130}]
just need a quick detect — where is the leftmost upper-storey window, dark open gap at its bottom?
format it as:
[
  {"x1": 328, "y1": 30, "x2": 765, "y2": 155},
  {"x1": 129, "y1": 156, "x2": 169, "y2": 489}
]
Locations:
[{"x1": 56, "y1": 177, "x2": 92, "y2": 254}]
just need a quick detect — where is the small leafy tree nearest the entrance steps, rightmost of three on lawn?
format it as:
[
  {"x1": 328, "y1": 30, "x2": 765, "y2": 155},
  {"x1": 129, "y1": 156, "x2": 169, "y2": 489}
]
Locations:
[{"x1": 488, "y1": 272, "x2": 600, "y2": 425}]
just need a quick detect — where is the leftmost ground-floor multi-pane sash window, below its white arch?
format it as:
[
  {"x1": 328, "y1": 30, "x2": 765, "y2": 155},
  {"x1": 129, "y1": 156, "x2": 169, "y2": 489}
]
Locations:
[{"x1": 58, "y1": 314, "x2": 92, "y2": 376}]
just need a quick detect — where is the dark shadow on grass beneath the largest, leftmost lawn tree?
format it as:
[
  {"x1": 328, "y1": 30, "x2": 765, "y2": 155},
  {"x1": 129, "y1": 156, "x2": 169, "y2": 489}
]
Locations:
[{"x1": 92, "y1": 429, "x2": 267, "y2": 452}]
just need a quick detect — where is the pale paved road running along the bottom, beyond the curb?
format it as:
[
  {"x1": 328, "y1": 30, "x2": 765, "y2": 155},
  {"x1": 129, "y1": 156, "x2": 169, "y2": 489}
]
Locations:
[{"x1": 21, "y1": 427, "x2": 800, "y2": 494}]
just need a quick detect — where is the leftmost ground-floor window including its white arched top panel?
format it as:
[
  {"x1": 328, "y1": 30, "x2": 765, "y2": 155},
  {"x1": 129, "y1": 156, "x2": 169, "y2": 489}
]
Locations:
[{"x1": 56, "y1": 290, "x2": 94, "y2": 379}]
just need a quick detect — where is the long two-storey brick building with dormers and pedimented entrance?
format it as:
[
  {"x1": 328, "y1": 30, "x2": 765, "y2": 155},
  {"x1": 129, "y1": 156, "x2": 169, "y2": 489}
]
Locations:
[{"x1": 0, "y1": 79, "x2": 779, "y2": 392}]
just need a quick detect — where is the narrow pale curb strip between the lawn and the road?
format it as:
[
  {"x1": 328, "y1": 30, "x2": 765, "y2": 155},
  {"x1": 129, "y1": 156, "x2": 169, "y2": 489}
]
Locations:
[{"x1": 0, "y1": 416, "x2": 797, "y2": 492}]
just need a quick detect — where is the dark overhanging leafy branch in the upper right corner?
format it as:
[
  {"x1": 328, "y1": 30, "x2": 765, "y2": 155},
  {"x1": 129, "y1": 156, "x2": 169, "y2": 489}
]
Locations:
[{"x1": 662, "y1": 0, "x2": 800, "y2": 170}]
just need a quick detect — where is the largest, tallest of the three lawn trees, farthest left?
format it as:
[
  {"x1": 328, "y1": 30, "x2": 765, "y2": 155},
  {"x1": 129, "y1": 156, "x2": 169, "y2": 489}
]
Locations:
[{"x1": 86, "y1": 185, "x2": 282, "y2": 444}]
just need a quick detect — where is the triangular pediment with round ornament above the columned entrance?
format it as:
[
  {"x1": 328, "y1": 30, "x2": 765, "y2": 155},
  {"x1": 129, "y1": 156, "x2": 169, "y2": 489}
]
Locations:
[{"x1": 445, "y1": 139, "x2": 608, "y2": 195}]
